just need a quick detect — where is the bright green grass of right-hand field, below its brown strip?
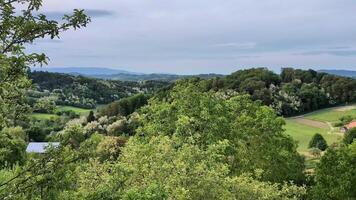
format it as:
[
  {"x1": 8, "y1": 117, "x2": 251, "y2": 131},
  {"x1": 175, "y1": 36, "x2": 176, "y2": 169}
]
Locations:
[{"x1": 285, "y1": 119, "x2": 342, "y2": 152}]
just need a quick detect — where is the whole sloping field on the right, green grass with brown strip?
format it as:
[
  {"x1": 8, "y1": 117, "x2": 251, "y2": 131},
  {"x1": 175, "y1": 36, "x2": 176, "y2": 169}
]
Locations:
[{"x1": 285, "y1": 105, "x2": 356, "y2": 153}]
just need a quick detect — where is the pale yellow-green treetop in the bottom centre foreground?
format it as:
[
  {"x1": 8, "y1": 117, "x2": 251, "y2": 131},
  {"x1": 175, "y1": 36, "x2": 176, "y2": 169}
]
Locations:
[{"x1": 74, "y1": 136, "x2": 305, "y2": 200}]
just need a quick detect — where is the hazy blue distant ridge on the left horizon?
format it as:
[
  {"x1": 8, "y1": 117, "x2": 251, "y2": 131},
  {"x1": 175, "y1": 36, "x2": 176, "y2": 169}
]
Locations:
[{"x1": 32, "y1": 67, "x2": 143, "y2": 76}]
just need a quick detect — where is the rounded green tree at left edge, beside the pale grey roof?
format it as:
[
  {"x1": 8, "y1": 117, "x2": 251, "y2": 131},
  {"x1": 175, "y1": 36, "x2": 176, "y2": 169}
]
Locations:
[{"x1": 0, "y1": 127, "x2": 26, "y2": 168}]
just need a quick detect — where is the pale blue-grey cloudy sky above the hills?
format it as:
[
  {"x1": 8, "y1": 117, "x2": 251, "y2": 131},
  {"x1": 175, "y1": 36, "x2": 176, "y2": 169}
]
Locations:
[{"x1": 28, "y1": 0, "x2": 356, "y2": 74}]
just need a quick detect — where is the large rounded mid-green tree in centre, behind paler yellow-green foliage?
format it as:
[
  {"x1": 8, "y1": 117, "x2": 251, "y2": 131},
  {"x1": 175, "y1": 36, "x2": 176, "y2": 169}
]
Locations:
[{"x1": 138, "y1": 81, "x2": 304, "y2": 182}]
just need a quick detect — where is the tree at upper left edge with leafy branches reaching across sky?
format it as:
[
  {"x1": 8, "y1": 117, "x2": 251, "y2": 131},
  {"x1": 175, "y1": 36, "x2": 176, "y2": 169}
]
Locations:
[{"x1": 0, "y1": 0, "x2": 90, "y2": 129}]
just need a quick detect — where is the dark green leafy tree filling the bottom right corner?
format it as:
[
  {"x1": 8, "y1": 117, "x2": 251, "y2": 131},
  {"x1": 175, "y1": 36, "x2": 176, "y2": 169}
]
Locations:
[{"x1": 311, "y1": 142, "x2": 356, "y2": 200}]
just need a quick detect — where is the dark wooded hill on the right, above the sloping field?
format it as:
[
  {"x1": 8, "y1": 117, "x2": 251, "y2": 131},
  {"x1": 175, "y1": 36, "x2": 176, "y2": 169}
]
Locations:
[{"x1": 154, "y1": 68, "x2": 356, "y2": 116}]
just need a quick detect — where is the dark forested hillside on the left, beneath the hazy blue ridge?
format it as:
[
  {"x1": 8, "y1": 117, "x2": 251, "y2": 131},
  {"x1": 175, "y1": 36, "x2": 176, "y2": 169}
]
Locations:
[{"x1": 28, "y1": 71, "x2": 169, "y2": 108}]
